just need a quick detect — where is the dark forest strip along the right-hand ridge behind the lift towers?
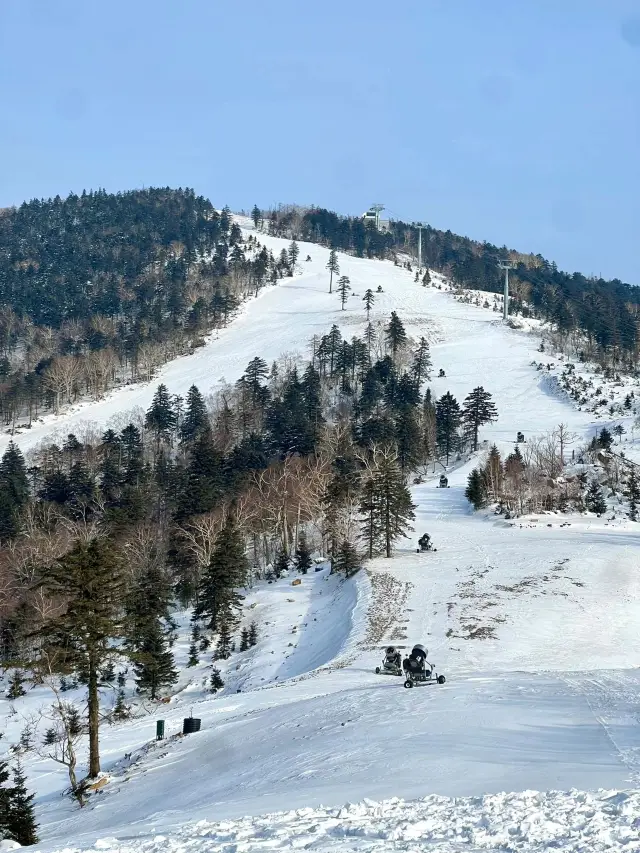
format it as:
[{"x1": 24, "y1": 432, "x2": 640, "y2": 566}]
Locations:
[{"x1": 262, "y1": 207, "x2": 640, "y2": 370}]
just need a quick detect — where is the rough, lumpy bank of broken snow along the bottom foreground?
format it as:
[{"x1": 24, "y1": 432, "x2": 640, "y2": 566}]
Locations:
[{"x1": 47, "y1": 791, "x2": 640, "y2": 853}]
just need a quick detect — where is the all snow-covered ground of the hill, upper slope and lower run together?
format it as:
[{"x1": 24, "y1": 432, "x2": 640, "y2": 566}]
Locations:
[{"x1": 0, "y1": 223, "x2": 640, "y2": 853}]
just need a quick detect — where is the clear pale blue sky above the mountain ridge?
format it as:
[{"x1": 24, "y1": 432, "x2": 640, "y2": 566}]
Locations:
[{"x1": 0, "y1": 0, "x2": 640, "y2": 284}]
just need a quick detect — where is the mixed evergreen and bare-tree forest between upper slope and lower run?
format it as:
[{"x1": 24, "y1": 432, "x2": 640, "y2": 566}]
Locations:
[{"x1": 0, "y1": 308, "x2": 497, "y2": 800}]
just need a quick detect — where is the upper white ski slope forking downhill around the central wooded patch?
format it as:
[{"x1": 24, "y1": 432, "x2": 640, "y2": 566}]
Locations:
[{"x1": 0, "y1": 219, "x2": 593, "y2": 460}]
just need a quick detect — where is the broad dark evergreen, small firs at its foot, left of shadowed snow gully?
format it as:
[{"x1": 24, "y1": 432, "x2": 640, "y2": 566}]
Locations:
[{"x1": 194, "y1": 514, "x2": 249, "y2": 631}]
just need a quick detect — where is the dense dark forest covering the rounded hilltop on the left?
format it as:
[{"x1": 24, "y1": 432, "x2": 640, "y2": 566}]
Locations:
[{"x1": 0, "y1": 189, "x2": 292, "y2": 428}]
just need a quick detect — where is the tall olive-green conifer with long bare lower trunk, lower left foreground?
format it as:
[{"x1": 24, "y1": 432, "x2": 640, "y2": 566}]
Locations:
[{"x1": 41, "y1": 539, "x2": 125, "y2": 778}]
